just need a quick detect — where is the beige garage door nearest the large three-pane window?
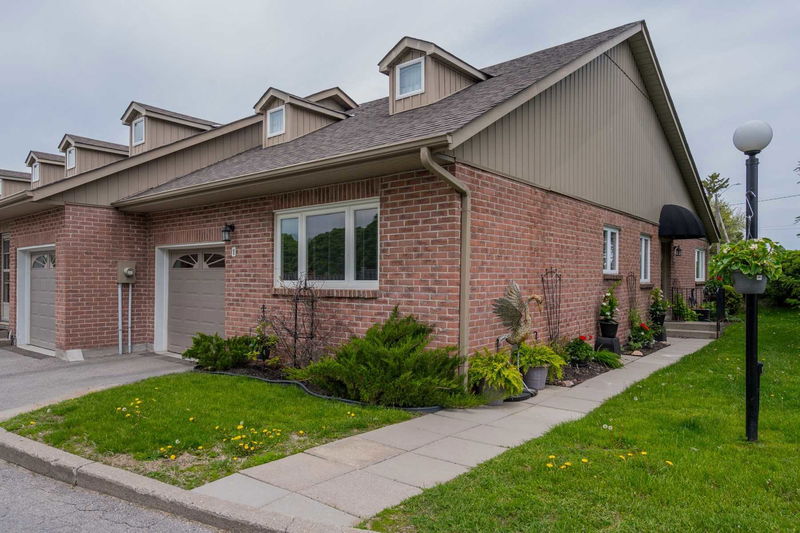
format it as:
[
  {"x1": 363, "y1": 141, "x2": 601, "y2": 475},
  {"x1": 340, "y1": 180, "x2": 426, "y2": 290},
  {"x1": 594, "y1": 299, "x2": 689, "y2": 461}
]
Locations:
[{"x1": 167, "y1": 248, "x2": 225, "y2": 353}]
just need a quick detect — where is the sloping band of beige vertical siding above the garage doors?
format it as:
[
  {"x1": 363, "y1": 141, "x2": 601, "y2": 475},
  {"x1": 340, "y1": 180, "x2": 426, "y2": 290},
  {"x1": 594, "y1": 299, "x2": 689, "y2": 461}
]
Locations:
[{"x1": 53, "y1": 122, "x2": 262, "y2": 205}]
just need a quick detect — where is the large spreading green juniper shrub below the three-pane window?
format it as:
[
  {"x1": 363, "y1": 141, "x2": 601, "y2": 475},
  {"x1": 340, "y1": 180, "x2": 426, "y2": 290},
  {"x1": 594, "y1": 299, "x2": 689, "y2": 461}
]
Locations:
[{"x1": 288, "y1": 308, "x2": 470, "y2": 407}]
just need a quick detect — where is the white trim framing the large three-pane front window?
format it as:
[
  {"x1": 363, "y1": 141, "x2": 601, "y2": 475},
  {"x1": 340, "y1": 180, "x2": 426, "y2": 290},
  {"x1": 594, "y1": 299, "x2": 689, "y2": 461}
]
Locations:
[{"x1": 273, "y1": 198, "x2": 381, "y2": 290}]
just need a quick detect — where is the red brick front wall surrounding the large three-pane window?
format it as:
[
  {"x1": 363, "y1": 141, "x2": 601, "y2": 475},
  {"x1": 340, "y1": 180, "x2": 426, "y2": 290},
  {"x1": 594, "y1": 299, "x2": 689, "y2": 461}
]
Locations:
[{"x1": 151, "y1": 172, "x2": 460, "y2": 352}]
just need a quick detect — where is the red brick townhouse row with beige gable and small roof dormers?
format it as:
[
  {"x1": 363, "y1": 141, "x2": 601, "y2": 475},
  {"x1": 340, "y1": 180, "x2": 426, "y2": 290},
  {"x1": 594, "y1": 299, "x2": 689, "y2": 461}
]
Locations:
[{"x1": 0, "y1": 22, "x2": 717, "y2": 359}]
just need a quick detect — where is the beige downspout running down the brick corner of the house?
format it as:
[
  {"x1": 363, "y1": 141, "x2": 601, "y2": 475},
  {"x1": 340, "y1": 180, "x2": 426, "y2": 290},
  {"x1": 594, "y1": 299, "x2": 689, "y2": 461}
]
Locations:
[{"x1": 419, "y1": 146, "x2": 471, "y2": 366}]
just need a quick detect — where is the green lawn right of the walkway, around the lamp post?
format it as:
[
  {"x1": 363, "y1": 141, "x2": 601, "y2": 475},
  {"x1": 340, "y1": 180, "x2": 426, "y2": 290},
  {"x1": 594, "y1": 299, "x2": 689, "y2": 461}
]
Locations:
[{"x1": 369, "y1": 309, "x2": 800, "y2": 533}]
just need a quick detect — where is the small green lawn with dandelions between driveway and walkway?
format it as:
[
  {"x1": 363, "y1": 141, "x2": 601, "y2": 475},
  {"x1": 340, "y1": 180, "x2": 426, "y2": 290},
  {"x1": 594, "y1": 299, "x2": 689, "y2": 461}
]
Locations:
[{"x1": 2, "y1": 373, "x2": 412, "y2": 488}]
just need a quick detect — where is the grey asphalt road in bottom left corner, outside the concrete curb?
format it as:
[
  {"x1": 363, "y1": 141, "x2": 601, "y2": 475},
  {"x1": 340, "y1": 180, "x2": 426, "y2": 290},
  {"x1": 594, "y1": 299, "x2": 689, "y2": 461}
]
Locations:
[{"x1": 0, "y1": 461, "x2": 217, "y2": 533}]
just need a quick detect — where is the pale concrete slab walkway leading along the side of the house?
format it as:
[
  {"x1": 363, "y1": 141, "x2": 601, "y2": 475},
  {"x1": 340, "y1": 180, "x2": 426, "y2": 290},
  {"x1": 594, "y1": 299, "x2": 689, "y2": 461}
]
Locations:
[{"x1": 194, "y1": 339, "x2": 711, "y2": 525}]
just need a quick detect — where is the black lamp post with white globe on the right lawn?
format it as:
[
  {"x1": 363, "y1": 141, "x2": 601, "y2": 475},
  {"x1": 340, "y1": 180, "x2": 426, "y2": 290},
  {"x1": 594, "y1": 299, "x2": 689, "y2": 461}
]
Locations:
[{"x1": 733, "y1": 120, "x2": 772, "y2": 441}]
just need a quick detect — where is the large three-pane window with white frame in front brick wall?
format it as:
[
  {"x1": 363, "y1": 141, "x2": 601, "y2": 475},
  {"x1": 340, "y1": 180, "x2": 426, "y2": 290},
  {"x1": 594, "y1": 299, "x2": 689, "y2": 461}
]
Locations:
[{"x1": 275, "y1": 199, "x2": 378, "y2": 289}]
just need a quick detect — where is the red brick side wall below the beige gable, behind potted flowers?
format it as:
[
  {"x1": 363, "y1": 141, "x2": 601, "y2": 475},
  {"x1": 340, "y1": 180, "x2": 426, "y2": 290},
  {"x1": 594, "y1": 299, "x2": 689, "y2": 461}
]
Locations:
[{"x1": 454, "y1": 164, "x2": 704, "y2": 349}]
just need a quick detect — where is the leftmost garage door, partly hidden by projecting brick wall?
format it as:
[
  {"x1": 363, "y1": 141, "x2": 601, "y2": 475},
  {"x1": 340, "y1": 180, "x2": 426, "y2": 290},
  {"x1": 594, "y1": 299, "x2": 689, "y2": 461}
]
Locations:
[{"x1": 30, "y1": 251, "x2": 56, "y2": 350}]
